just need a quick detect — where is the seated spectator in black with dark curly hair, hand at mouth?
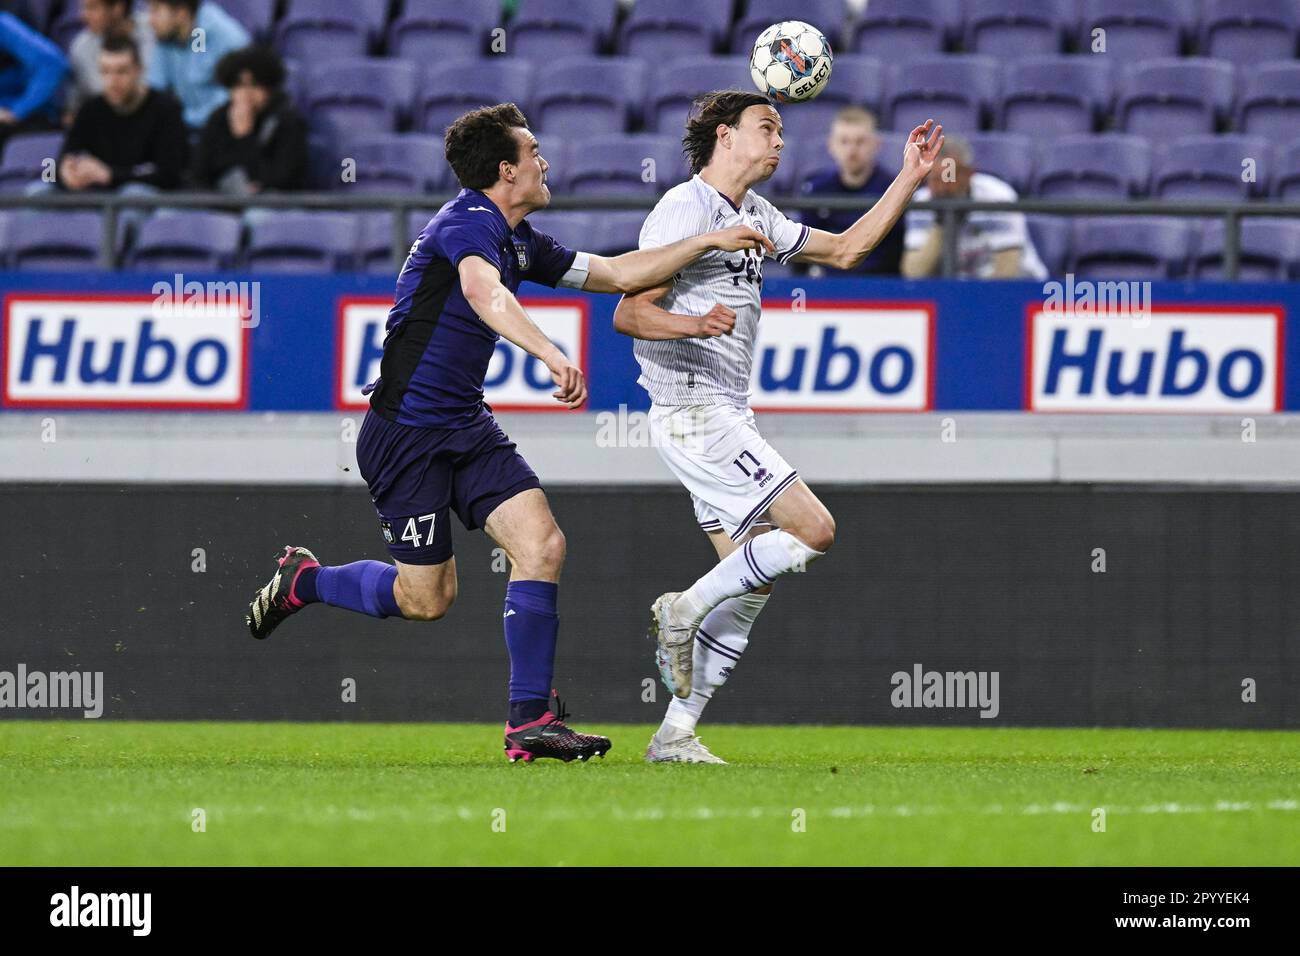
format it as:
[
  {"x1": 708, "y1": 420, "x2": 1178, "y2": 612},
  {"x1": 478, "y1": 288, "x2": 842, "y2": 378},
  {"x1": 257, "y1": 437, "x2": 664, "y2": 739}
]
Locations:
[{"x1": 194, "y1": 47, "x2": 307, "y2": 195}]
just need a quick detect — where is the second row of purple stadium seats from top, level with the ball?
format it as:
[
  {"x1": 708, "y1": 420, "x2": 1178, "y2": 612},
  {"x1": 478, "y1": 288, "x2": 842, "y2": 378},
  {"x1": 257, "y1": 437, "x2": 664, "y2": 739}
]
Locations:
[{"x1": 131, "y1": 55, "x2": 1300, "y2": 139}]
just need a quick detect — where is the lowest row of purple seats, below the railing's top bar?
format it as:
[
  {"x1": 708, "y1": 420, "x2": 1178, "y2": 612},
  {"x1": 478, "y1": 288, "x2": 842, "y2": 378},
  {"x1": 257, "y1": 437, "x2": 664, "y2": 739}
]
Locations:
[{"x1": 0, "y1": 209, "x2": 1300, "y2": 281}]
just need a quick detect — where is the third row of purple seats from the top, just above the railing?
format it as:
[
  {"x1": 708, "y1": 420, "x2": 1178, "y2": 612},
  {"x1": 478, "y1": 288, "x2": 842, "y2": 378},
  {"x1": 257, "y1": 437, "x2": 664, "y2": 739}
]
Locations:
[{"x1": 0, "y1": 131, "x2": 1300, "y2": 202}]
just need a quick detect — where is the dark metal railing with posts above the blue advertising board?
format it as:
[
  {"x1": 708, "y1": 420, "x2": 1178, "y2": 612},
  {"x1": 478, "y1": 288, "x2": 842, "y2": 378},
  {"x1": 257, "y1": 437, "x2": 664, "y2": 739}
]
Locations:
[{"x1": 0, "y1": 193, "x2": 1300, "y2": 280}]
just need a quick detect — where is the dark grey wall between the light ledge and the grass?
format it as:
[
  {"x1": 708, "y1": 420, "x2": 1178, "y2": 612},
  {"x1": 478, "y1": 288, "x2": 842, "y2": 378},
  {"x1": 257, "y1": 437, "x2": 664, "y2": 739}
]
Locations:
[{"x1": 0, "y1": 484, "x2": 1300, "y2": 728}]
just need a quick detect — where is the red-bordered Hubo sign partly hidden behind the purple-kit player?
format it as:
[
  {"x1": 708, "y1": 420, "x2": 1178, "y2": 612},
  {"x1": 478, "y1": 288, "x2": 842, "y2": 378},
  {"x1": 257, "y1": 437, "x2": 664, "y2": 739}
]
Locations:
[{"x1": 334, "y1": 297, "x2": 588, "y2": 411}]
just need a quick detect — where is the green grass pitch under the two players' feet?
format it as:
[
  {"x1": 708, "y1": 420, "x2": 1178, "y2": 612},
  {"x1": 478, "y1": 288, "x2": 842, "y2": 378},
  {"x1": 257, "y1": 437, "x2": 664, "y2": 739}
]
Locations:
[{"x1": 0, "y1": 721, "x2": 1300, "y2": 866}]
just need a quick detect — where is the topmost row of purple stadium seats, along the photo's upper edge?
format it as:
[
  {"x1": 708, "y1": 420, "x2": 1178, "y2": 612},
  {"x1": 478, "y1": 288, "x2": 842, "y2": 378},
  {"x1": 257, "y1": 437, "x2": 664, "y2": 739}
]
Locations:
[{"x1": 29, "y1": 0, "x2": 1300, "y2": 64}]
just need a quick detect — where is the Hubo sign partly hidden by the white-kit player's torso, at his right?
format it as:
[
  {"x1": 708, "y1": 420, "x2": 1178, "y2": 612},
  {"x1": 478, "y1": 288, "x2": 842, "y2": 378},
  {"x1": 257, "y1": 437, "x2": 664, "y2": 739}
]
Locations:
[{"x1": 750, "y1": 300, "x2": 935, "y2": 411}]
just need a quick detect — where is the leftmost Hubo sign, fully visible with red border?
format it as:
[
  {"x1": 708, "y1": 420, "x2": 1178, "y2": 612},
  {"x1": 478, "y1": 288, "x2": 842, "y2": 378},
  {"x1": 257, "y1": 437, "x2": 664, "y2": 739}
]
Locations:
[{"x1": 4, "y1": 293, "x2": 251, "y2": 408}]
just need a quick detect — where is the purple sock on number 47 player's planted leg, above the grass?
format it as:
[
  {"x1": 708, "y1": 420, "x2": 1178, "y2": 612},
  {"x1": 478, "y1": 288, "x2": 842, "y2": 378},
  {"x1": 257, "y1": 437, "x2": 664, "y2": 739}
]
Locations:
[{"x1": 506, "y1": 581, "x2": 560, "y2": 727}]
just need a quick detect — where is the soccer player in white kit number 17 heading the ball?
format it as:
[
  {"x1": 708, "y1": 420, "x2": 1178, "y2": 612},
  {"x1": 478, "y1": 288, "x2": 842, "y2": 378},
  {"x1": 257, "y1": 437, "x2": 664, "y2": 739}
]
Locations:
[{"x1": 614, "y1": 90, "x2": 944, "y2": 763}]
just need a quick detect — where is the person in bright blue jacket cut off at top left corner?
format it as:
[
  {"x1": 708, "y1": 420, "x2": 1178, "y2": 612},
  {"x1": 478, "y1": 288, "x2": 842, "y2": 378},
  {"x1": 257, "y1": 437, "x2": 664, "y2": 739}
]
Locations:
[{"x1": 0, "y1": 12, "x2": 68, "y2": 147}]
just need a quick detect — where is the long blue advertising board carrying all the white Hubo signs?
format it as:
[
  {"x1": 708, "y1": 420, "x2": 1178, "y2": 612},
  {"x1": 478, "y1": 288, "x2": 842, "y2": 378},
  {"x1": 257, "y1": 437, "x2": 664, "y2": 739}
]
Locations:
[{"x1": 0, "y1": 273, "x2": 1300, "y2": 416}]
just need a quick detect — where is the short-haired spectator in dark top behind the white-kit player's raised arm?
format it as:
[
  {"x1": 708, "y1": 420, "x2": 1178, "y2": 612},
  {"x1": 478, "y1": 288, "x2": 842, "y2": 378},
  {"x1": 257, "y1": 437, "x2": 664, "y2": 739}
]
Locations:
[{"x1": 801, "y1": 107, "x2": 904, "y2": 276}]
